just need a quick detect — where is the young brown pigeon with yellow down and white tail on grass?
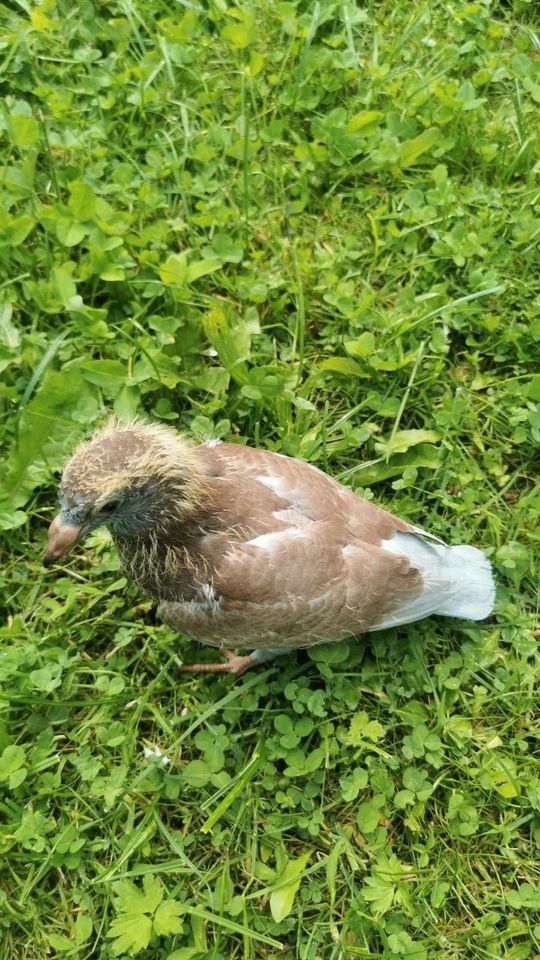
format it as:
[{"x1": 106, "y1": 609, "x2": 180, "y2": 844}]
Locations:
[{"x1": 44, "y1": 420, "x2": 495, "y2": 675}]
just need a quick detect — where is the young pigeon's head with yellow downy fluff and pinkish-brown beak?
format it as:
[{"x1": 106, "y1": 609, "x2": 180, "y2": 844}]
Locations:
[{"x1": 44, "y1": 420, "x2": 204, "y2": 566}]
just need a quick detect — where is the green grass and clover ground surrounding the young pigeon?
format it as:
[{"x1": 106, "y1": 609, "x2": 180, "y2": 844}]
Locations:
[{"x1": 0, "y1": 0, "x2": 540, "y2": 960}]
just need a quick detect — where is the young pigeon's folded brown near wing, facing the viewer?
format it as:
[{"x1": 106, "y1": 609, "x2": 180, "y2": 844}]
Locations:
[{"x1": 209, "y1": 520, "x2": 422, "y2": 646}]
